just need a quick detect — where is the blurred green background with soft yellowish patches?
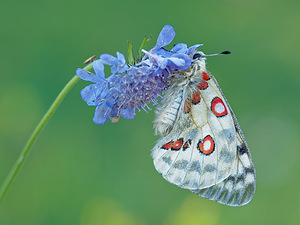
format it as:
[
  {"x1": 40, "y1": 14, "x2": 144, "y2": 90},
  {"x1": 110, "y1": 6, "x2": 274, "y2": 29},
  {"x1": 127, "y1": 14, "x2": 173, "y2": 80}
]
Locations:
[{"x1": 0, "y1": 0, "x2": 300, "y2": 225}]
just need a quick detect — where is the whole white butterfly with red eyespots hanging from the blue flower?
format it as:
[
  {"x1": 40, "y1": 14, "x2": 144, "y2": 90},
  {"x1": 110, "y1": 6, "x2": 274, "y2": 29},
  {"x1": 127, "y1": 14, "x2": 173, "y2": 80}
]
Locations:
[{"x1": 152, "y1": 51, "x2": 256, "y2": 206}]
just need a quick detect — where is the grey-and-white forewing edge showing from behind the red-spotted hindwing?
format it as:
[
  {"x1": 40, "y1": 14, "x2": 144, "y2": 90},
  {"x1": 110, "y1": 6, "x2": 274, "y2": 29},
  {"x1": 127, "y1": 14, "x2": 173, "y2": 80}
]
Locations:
[{"x1": 193, "y1": 73, "x2": 256, "y2": 206}]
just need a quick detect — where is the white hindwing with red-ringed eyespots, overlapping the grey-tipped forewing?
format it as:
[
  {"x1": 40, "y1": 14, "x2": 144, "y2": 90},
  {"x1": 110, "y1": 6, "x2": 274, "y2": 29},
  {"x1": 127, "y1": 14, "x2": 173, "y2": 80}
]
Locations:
[{"x1": 152, "y1": 71, "x2": 237, "y2": 190}]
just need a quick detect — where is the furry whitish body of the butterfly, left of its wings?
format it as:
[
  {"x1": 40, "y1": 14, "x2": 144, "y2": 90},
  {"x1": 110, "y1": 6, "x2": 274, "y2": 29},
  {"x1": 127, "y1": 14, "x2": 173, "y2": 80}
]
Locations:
[{"x1": 154, "y1": 58, "x2": 207, "y2": 135}]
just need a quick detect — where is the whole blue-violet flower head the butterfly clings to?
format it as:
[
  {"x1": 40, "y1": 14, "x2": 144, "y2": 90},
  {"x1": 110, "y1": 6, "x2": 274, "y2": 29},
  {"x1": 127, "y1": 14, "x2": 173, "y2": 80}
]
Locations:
[{"x1": 76, "y1": 25, "x2": 200, "y2": 125}]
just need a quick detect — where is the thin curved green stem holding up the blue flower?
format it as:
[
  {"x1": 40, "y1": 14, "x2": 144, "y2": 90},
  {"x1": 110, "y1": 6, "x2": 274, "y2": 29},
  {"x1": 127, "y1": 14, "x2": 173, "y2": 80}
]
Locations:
[{"x1": 0, "y1": 64, "x2": 92, "y2": 202}]
